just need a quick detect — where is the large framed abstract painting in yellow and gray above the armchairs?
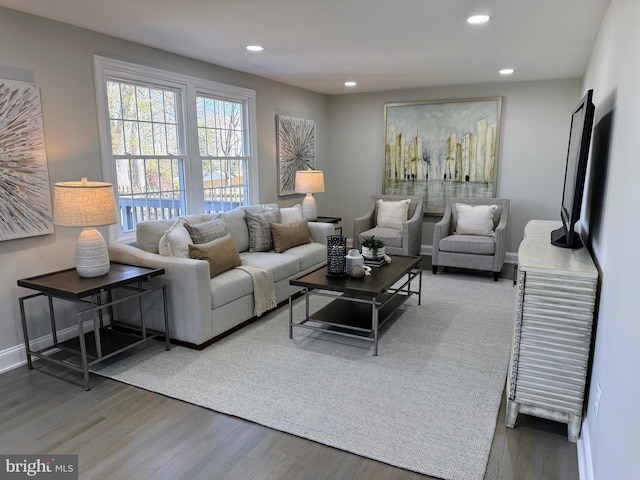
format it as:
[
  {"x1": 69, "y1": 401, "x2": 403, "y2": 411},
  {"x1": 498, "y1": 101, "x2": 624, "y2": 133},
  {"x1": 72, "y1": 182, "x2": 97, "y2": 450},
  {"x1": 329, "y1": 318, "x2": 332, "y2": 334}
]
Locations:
[{"x1": 383, "y1": 97, "x2": 502, "y2": 216}]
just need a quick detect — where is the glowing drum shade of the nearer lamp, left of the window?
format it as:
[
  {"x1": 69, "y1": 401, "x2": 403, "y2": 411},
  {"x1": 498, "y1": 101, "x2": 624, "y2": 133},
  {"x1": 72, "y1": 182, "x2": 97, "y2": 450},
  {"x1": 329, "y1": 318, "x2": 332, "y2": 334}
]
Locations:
[{"x1": 53, "y1": 178, "x2": 118, "y2": 227}]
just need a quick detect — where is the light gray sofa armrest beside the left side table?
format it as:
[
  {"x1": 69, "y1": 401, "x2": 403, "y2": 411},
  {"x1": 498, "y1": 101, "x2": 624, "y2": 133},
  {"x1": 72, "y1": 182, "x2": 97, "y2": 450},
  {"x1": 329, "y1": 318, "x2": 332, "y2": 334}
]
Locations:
[{"x1": 108, "y1": 244, "x2": 211, "y2": 345}]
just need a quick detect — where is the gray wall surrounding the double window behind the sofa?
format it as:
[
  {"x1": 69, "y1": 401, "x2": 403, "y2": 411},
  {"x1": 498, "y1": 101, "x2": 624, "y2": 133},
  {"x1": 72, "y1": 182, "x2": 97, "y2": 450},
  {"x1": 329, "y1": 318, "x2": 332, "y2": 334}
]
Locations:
[{"x1": 0, "y1": 8, "x2": 328, "y2": 360}]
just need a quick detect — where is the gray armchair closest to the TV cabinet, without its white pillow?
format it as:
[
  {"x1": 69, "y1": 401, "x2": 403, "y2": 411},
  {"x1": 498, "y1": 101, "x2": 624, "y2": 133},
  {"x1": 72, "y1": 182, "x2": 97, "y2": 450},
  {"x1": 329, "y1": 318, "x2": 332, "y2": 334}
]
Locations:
[{"x1": 431, "y1": 198, "x2": 509, "y2": 280}]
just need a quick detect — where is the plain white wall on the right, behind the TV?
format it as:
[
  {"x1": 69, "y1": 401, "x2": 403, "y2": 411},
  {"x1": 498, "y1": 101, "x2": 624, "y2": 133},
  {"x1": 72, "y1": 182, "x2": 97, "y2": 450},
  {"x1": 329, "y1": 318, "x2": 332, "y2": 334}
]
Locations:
[{"x1": 582, "y1": 0, "x2": 640, "y2": 480}]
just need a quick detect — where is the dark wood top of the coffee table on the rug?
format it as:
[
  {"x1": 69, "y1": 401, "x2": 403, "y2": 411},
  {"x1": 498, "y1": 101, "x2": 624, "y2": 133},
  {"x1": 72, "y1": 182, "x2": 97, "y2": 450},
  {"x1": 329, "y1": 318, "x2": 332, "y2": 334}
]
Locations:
[{"x1": 289, "y1": 255, "x2": 421, "y2": 297}]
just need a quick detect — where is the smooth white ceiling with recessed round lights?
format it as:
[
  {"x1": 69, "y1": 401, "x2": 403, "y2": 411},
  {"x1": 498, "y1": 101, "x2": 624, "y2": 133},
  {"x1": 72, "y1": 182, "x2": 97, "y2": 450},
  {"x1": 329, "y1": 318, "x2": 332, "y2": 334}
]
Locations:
[{"x1": 0, "y1": 0, "x2": 609, "y2": 94}]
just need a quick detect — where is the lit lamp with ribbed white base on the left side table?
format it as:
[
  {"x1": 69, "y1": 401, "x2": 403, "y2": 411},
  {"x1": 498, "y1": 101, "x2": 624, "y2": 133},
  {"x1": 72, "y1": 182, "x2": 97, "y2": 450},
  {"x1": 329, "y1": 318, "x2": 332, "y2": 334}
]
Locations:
[{"x1": 53, "y1": 178, "x2": 118, "y2": 278}]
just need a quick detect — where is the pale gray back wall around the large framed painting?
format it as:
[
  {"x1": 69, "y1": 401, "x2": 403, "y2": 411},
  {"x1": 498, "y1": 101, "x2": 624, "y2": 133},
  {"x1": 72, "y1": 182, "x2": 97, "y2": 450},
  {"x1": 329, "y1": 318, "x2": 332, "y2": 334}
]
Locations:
[{"x1": 328, "y1": 79, "x2": 582, "y2": 252}]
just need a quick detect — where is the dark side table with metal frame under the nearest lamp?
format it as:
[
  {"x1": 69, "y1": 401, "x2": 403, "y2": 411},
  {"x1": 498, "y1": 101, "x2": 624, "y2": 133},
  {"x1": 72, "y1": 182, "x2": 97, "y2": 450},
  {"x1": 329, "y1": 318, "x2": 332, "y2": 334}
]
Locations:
[{"x1": 18, "y1": 262, "x2": 171, "y2": 390}]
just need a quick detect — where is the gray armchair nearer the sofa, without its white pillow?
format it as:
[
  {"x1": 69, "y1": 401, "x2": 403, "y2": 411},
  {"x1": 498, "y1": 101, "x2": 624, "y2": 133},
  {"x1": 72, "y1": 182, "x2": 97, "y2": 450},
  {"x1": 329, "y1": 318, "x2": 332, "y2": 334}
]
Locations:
[{"x1": 353, "y1": 195, "x2": 424, "y2": 256}]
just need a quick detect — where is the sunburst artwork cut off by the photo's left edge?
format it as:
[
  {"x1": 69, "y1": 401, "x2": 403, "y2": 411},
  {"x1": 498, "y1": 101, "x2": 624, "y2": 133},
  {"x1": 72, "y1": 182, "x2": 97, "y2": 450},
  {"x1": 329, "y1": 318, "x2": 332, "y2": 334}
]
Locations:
[{"x1": 0, "y1": 79, "x2": 53, "y2": 241}]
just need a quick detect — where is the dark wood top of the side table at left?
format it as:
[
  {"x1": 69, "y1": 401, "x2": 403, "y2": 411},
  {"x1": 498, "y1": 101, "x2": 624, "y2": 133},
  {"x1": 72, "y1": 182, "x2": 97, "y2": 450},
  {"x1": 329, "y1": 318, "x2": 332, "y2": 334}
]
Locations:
[{"x1": 18, "y1": 262, "x2": 164, "y2": 300}]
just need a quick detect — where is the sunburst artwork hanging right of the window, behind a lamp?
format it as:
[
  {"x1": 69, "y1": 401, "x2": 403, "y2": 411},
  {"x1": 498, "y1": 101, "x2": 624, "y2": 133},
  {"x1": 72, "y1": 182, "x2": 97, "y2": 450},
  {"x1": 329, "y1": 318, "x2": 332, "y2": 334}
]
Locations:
[{"x1": 276, "y1": 115, "x2": 316, "y2": 196}]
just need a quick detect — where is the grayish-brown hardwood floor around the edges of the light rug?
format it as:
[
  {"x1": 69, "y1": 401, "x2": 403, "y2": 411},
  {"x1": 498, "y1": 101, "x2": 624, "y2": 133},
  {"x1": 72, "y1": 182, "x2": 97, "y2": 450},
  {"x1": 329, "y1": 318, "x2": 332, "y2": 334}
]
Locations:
[{"x1": 0, "y1": 362, "x2": 578, "y2": 480}]
